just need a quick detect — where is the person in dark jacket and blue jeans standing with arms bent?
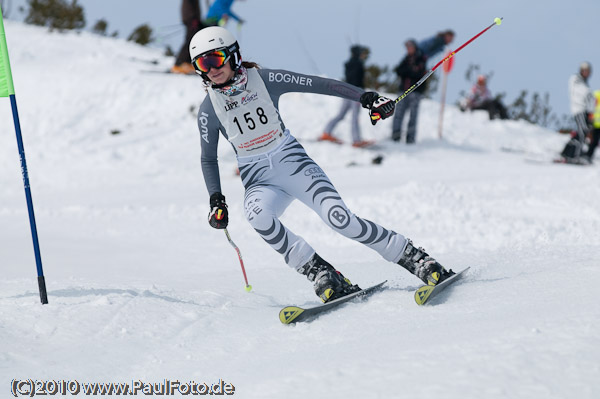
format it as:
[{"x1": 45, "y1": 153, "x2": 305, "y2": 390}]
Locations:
[{"x1": 392, "y1": 39, "x2": 427, "y2": 144}]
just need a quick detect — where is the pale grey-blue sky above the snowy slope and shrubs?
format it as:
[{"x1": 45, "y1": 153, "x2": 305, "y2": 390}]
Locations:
[{"x1": 3, "y1": 0, "x2": 600, "y2": 127}]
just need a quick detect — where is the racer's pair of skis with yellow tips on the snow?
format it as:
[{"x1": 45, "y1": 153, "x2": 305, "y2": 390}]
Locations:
[{"x1": 279, "y1": 267, "x2": 469, "y2": 324}]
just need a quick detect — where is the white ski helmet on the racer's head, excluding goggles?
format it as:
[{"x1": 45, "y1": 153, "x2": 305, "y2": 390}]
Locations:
[{"x1": 190, "y1": 26, "x2": 242, "y2": 80}]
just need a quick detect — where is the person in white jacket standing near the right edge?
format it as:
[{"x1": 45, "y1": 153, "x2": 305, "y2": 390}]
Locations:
[{"x1": 561, "y1": 62, "x2": 594, "y2": 163}]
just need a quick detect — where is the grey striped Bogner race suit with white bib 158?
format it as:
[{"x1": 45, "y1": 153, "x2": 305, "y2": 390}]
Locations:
[{"x1": 198, "y1": 68, "x2": 406, "y2": 269}]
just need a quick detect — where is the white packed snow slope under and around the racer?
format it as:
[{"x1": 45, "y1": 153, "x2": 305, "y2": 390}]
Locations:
[{"x1": 0, "y1": 22, "x2": 600, "y2": 399}]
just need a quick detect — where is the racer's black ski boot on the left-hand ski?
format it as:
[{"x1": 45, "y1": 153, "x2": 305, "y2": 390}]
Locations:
[{"x1": 298, "y1": 253, "x2": 360, "y2": 303}]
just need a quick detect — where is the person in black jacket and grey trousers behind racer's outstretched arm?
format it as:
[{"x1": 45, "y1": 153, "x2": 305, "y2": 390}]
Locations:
[{"x1": 319, "y1": 45, "x2": 373, "y2": 148}]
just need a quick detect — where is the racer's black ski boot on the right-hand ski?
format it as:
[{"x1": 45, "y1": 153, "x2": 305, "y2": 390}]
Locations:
[{"x1": 398, "y1": 240, "x2": 456, "y2": 285}]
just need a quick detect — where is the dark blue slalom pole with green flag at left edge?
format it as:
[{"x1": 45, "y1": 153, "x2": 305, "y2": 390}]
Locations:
[{"x1": 0, "y1": 7, "x2": 48, "y2": 304}]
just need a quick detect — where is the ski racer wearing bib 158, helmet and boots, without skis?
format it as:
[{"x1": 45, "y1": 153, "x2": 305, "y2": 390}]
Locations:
[{"x1": 190, "y1": 27, "x2": 453, "y2": 302}]
